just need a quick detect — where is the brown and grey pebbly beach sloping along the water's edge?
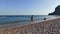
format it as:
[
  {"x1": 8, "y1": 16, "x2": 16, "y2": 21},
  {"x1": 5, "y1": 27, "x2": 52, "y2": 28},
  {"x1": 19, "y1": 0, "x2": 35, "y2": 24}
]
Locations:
[{"x1": 0, "y1": 18, "x2": 60, "y2": 34}]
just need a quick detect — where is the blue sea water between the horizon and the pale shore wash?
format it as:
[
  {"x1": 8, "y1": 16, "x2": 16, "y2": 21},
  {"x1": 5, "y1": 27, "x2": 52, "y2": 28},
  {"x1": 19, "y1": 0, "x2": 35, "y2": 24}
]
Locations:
[{"x1": 0, "y1": 15, "x2": 58, "y2": 24}]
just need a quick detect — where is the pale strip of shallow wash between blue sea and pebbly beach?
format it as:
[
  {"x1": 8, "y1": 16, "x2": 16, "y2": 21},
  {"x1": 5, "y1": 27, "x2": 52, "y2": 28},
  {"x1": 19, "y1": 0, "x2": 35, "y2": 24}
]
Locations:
[{"x1": 0, "y1": 17, "x2": 60, "y2": 30}]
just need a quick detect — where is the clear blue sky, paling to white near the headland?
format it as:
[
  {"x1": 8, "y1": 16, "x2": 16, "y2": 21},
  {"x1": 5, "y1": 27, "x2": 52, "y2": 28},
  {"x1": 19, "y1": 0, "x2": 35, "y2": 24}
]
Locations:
[{"x1": 0, "y1": 0, "x2": 60, "y2": 15}]
